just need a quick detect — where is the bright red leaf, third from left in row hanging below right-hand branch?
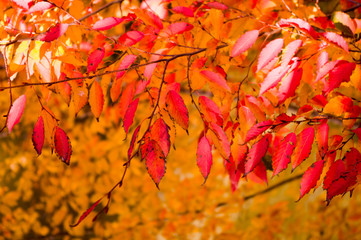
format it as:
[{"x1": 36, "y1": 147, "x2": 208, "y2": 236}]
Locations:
[{"x1": 292, "y1": 127, "x2": 315, "y2": 171}]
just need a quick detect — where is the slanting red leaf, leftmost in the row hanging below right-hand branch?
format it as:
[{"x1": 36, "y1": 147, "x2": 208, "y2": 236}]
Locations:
[{"x1": 245, "y1": 134, "x2": 272, "y2": 175}]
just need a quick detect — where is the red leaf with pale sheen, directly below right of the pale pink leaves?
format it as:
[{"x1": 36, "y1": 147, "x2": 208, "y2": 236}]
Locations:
[{"x1": 278, "y1": 68, "x2": 302, "y2": 104}]
